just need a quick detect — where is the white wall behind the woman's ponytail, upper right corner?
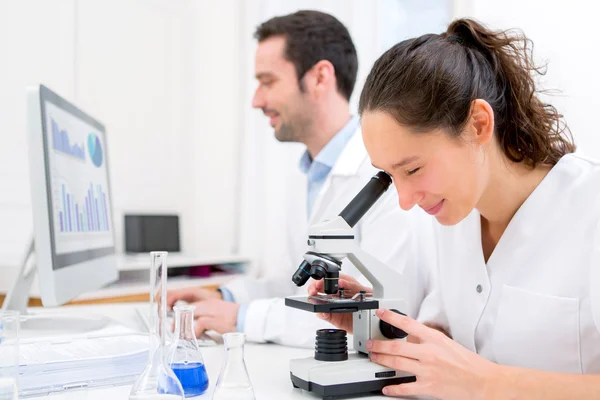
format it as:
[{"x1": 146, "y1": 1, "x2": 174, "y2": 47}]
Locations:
[{"x1": 455, "y1": 0, "x2": 600, "y2": 158}]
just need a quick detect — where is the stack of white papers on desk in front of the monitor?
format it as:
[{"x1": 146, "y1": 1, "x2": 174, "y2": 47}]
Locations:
[{"x1": 19, "y1": 334, "x2": 148, "y2": 397}]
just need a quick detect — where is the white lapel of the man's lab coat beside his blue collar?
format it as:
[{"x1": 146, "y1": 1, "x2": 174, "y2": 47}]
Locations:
[{"x1": 309, "y1": 129, "x2": 368, "y2": 226}]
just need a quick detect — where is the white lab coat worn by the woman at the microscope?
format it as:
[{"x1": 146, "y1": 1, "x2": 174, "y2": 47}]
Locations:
[{"x1": 419, "y1": 154, "x2": 600, "y2": 374}]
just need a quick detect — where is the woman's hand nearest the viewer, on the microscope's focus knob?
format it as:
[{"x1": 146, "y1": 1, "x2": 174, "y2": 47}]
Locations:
[{"x1": 367, "y1": 309, "x2": 500, "y2": 400}]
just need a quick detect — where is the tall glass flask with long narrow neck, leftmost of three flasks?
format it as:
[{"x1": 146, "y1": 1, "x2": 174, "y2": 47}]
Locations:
[{"x1": 129, "y1": 251, "x2": 184, "y2": 400}]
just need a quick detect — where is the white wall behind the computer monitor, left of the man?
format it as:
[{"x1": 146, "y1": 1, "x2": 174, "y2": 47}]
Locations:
[{"x1": 0, "y1": 0, "x2": 240, "y2": 280}]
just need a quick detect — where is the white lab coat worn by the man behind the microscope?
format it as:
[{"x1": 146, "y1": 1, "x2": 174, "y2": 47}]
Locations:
[{"x1": 225, "y1": 130, "x2": 431, "y2": 347}]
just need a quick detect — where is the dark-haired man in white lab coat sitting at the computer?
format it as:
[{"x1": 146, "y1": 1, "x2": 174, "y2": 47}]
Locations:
[{"x1": 167, "y1": 11, "x2": 424, "y2": 346}]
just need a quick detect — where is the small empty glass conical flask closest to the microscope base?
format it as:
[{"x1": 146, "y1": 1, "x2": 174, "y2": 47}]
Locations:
[{"x1": 212, "y1": 332, "x2": 255, "y2": 400}]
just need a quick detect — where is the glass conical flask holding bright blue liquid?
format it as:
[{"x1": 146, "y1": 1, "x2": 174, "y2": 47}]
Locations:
[{"x1": 168, "y1": 305, "x2": 208, "y2": 398}]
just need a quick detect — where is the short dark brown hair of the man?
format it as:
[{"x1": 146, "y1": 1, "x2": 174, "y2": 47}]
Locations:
[{"x1": 254, "y1": 10, "x2": 358, "y2": 100}]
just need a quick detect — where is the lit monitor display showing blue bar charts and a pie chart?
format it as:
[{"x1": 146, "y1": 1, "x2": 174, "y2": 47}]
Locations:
[{"x1": 46, "y1": 103, "x2": 114, "y2": 254}]
